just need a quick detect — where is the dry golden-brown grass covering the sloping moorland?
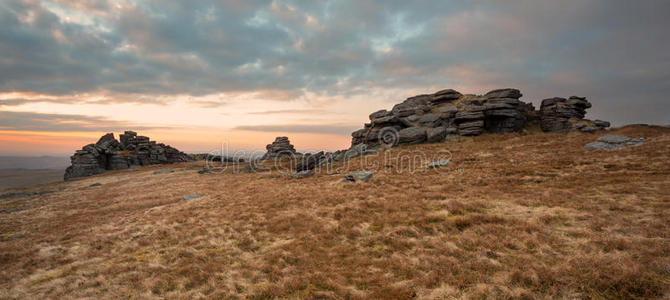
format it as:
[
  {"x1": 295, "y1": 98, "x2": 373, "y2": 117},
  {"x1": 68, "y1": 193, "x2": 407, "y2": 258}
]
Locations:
[{"x1": 0, "y1": 127, "x2": 670, "y2": 299}]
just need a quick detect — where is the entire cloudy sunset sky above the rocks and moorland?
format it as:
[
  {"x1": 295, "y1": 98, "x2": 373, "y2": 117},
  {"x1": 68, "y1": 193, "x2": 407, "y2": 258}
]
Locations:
[{"x1": 0, "y1": 0, "x2": 670, "y2": 155}]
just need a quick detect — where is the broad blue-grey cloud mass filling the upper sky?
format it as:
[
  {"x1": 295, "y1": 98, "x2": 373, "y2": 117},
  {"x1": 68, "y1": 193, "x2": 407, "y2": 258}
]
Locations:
[{"x1": 0, "y1": 0, "x2": 670, "y2": 123}]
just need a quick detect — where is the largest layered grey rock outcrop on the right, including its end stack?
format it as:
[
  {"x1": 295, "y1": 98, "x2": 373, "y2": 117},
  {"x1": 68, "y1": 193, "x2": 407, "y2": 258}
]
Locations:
[{"x1": 351, "y1": 88, "x2": 609, "y2": 147}]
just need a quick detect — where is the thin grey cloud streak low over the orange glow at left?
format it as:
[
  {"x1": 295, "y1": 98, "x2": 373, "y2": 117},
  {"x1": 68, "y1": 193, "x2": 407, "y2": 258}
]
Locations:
[{"x1": 0, "y1": 111, "x2": 160, "y2": 132}]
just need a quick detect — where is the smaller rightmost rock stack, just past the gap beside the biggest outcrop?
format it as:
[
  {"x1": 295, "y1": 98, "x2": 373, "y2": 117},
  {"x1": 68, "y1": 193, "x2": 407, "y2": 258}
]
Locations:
[{"x1": 538, "y1": 96, "x2": 610, "y2": 133}]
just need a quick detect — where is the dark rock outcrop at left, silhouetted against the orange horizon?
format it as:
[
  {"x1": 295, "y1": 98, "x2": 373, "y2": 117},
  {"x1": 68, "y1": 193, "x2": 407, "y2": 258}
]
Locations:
[{"x1": 64, "y1": 131, "x2": 192, "y2": 180}]
